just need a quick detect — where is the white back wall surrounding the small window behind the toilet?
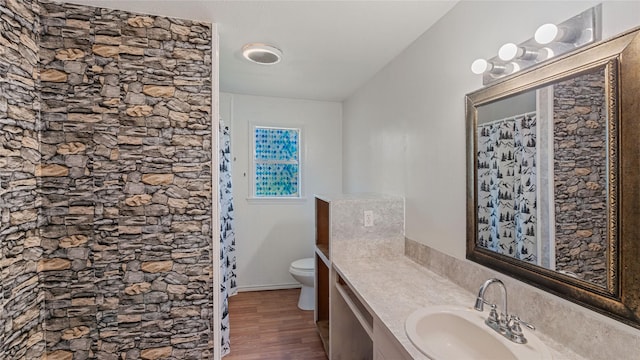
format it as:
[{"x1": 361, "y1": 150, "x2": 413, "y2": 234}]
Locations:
[{"x1": 220, "y1": 93, "x2": 342, "y2": 291}]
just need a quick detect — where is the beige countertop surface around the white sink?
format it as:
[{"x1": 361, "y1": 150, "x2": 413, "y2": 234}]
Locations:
[{"x1": 331, "y1": 240, "x2": 584, "y2": 360}]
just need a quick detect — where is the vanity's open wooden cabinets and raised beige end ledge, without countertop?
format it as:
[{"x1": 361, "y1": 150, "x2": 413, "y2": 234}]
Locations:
[{"x1": 315, "y1": 194, "x2": 412, "y2": 360}]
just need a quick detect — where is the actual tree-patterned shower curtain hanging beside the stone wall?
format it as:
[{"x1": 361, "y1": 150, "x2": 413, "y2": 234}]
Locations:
[{"x1": 219, "y1": 121, "x2": 237, "y2": 356}]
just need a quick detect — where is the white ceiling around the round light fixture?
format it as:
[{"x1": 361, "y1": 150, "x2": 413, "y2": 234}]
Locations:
[{"x1": 68, "y1": 0, "x2": 457, "y2": 101}]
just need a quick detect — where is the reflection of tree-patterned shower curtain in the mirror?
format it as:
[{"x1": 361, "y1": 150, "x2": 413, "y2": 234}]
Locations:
[{"x1": 477, "y1": 112, "x2": 538, "y2": 264}]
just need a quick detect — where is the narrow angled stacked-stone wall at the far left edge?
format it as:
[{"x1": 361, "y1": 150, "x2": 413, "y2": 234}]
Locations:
[{"x1": 0, "y1": 0, "x2": 44, "y2": 359}]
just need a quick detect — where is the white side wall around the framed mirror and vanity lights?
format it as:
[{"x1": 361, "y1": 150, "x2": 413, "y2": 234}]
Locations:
[{"x1": 343, "y1": 1, "x2": 640, "y2": 259}]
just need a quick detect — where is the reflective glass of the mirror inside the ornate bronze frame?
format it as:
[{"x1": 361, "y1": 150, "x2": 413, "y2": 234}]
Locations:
[{"x1": 475, "y1": 66, "x2": 616, "y2": 290}]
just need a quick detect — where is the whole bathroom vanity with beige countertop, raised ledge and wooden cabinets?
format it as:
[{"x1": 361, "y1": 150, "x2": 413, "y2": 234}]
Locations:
[{"x1": 315, "y1": 195, "x2": 583, "y2": 360}]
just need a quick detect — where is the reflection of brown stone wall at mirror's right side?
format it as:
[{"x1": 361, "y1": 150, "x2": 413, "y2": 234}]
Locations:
[{"x1": 554, "y1": 69, "x2": 608, "y2": 287}]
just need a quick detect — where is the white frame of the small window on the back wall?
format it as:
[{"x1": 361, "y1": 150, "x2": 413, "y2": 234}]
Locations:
[{"x1": 248, "y1": 123, "x2": 305, "y2": 202}]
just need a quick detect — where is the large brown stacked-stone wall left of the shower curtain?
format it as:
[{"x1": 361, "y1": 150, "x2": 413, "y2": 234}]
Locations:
[{"x1": 0, "y1": 0, "x2": 214, "y2": 360}]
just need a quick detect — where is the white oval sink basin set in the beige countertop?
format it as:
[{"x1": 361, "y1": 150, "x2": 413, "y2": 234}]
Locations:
[{"x1": 405, "y1": 306, "x2": 552, "y2": 360}]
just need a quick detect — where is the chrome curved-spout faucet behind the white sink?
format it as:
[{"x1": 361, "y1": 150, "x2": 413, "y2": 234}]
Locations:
[{"x1": 474, "y1": 278, "x2": 536, "y2": 344}]
